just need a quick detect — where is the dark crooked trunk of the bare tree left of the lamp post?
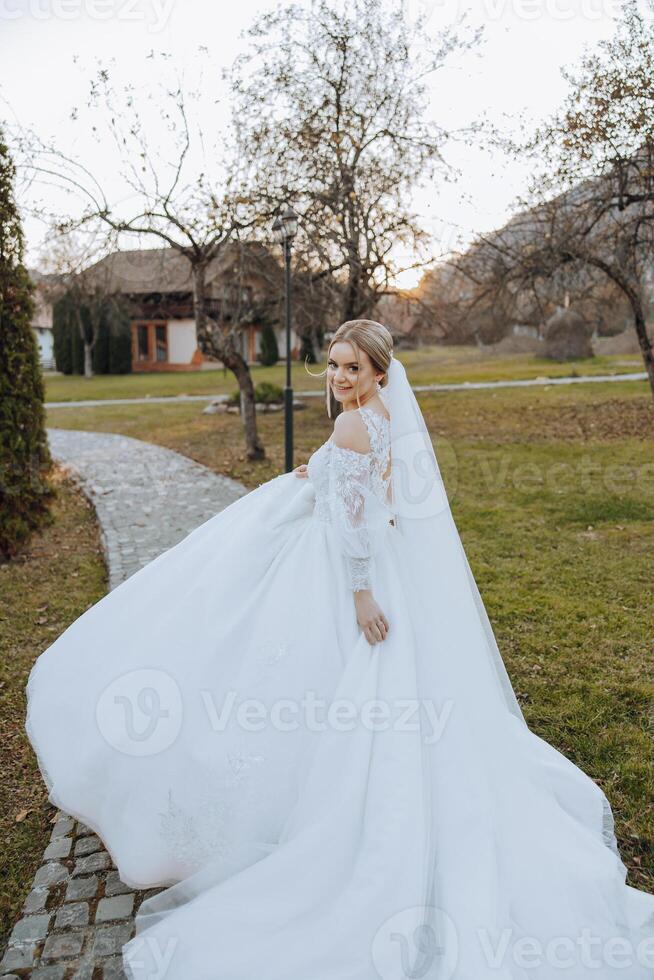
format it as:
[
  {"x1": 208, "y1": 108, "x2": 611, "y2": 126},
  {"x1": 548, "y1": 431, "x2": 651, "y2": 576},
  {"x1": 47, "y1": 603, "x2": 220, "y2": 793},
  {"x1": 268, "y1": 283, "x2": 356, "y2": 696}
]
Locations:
[{"x1": 191, "y1": 262, "x2": 266, "y2": 460}]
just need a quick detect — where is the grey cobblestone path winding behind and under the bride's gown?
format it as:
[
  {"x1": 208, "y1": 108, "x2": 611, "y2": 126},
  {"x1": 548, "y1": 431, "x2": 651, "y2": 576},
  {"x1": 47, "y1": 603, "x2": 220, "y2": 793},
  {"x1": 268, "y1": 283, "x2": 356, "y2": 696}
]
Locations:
[{"x1": 0, "y1": 429, "x2": 247, "y2": 980}]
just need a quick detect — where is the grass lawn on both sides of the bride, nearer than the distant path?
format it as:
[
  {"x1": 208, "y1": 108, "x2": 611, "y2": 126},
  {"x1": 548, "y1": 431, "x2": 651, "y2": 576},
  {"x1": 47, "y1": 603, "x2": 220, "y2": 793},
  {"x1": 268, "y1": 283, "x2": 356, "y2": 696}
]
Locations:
[{"x1": 0, "y1": 368, "x2": 654, "y2": 940}]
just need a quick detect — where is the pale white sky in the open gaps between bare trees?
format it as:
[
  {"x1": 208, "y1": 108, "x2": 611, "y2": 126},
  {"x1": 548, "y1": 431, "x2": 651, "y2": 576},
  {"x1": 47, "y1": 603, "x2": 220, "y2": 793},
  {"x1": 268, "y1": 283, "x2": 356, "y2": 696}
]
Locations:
[{"x1": 0, "y1": 0, "x2": 636, "y2": 286}]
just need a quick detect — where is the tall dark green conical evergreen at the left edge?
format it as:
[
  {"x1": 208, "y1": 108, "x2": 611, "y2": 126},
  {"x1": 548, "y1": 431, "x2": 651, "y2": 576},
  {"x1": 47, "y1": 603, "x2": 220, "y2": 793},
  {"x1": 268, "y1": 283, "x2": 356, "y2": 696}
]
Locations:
[{"x1": 0, "y1": 133, "x2": 54, "y2": 559}]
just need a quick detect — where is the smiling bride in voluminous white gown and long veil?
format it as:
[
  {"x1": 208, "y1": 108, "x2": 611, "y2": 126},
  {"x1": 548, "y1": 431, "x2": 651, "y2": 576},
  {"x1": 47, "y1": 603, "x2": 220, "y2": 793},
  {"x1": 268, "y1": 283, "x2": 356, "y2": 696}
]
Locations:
[{"x1": 26, "y1": 320, "x2": 654, "y2": 980}]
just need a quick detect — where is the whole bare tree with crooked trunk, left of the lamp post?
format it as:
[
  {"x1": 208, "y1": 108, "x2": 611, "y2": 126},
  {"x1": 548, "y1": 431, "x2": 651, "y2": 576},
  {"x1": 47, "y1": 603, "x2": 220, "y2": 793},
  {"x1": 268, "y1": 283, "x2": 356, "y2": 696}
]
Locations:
[{"x1": 16, "y1": 61, "x2": 272, "y2": 460}]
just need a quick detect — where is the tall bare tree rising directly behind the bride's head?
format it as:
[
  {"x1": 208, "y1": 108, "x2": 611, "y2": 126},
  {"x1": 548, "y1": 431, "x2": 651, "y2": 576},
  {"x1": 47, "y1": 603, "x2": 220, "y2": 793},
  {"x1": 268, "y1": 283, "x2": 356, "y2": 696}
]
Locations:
[{"x1": 231, "y1": 0, "x2": 478, "y2": 330}]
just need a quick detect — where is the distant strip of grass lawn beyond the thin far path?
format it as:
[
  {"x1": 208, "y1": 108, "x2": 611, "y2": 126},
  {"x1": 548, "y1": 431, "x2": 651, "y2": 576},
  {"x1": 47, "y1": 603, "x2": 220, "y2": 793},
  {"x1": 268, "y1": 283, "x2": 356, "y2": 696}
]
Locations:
[{"x1": 45, "y1": 346, "x2": 643, "y2": 402}]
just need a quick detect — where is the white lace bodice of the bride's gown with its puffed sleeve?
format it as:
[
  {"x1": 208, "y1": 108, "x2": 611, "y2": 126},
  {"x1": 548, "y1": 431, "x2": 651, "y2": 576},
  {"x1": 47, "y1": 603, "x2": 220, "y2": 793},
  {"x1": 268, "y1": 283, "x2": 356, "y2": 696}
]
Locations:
[{"x1": 308, "y1": 406, "x2": 392, "y2": 591}]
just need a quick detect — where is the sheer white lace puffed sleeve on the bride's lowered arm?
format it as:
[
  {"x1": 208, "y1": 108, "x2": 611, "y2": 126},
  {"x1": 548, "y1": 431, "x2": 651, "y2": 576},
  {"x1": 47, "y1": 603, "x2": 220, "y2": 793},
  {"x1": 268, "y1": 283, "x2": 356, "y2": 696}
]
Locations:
[{"x1": 329, "y1": 445, "x2": 390, "y2": 592}]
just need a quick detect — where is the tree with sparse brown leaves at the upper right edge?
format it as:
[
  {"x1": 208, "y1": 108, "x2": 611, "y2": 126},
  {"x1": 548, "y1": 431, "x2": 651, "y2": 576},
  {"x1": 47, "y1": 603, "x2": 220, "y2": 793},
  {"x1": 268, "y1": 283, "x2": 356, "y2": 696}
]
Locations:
[{"x1": 520, "y1": 0, "x2": 654, "y2": 394}]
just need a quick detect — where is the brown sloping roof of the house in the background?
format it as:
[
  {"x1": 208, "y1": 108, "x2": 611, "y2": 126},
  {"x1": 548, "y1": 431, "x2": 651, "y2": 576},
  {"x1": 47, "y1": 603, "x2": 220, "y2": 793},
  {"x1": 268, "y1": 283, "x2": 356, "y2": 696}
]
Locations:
[{"x1": 84, "y1": 242, "x2": 275, "y2": 295}]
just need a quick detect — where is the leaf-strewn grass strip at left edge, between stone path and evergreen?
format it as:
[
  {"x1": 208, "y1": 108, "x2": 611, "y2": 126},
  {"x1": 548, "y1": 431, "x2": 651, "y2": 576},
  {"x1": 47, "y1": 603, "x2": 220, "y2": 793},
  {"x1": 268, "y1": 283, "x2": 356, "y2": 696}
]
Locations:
[{"x1": 0, "y1": 470, "x2": 107, "y2": 947}]
